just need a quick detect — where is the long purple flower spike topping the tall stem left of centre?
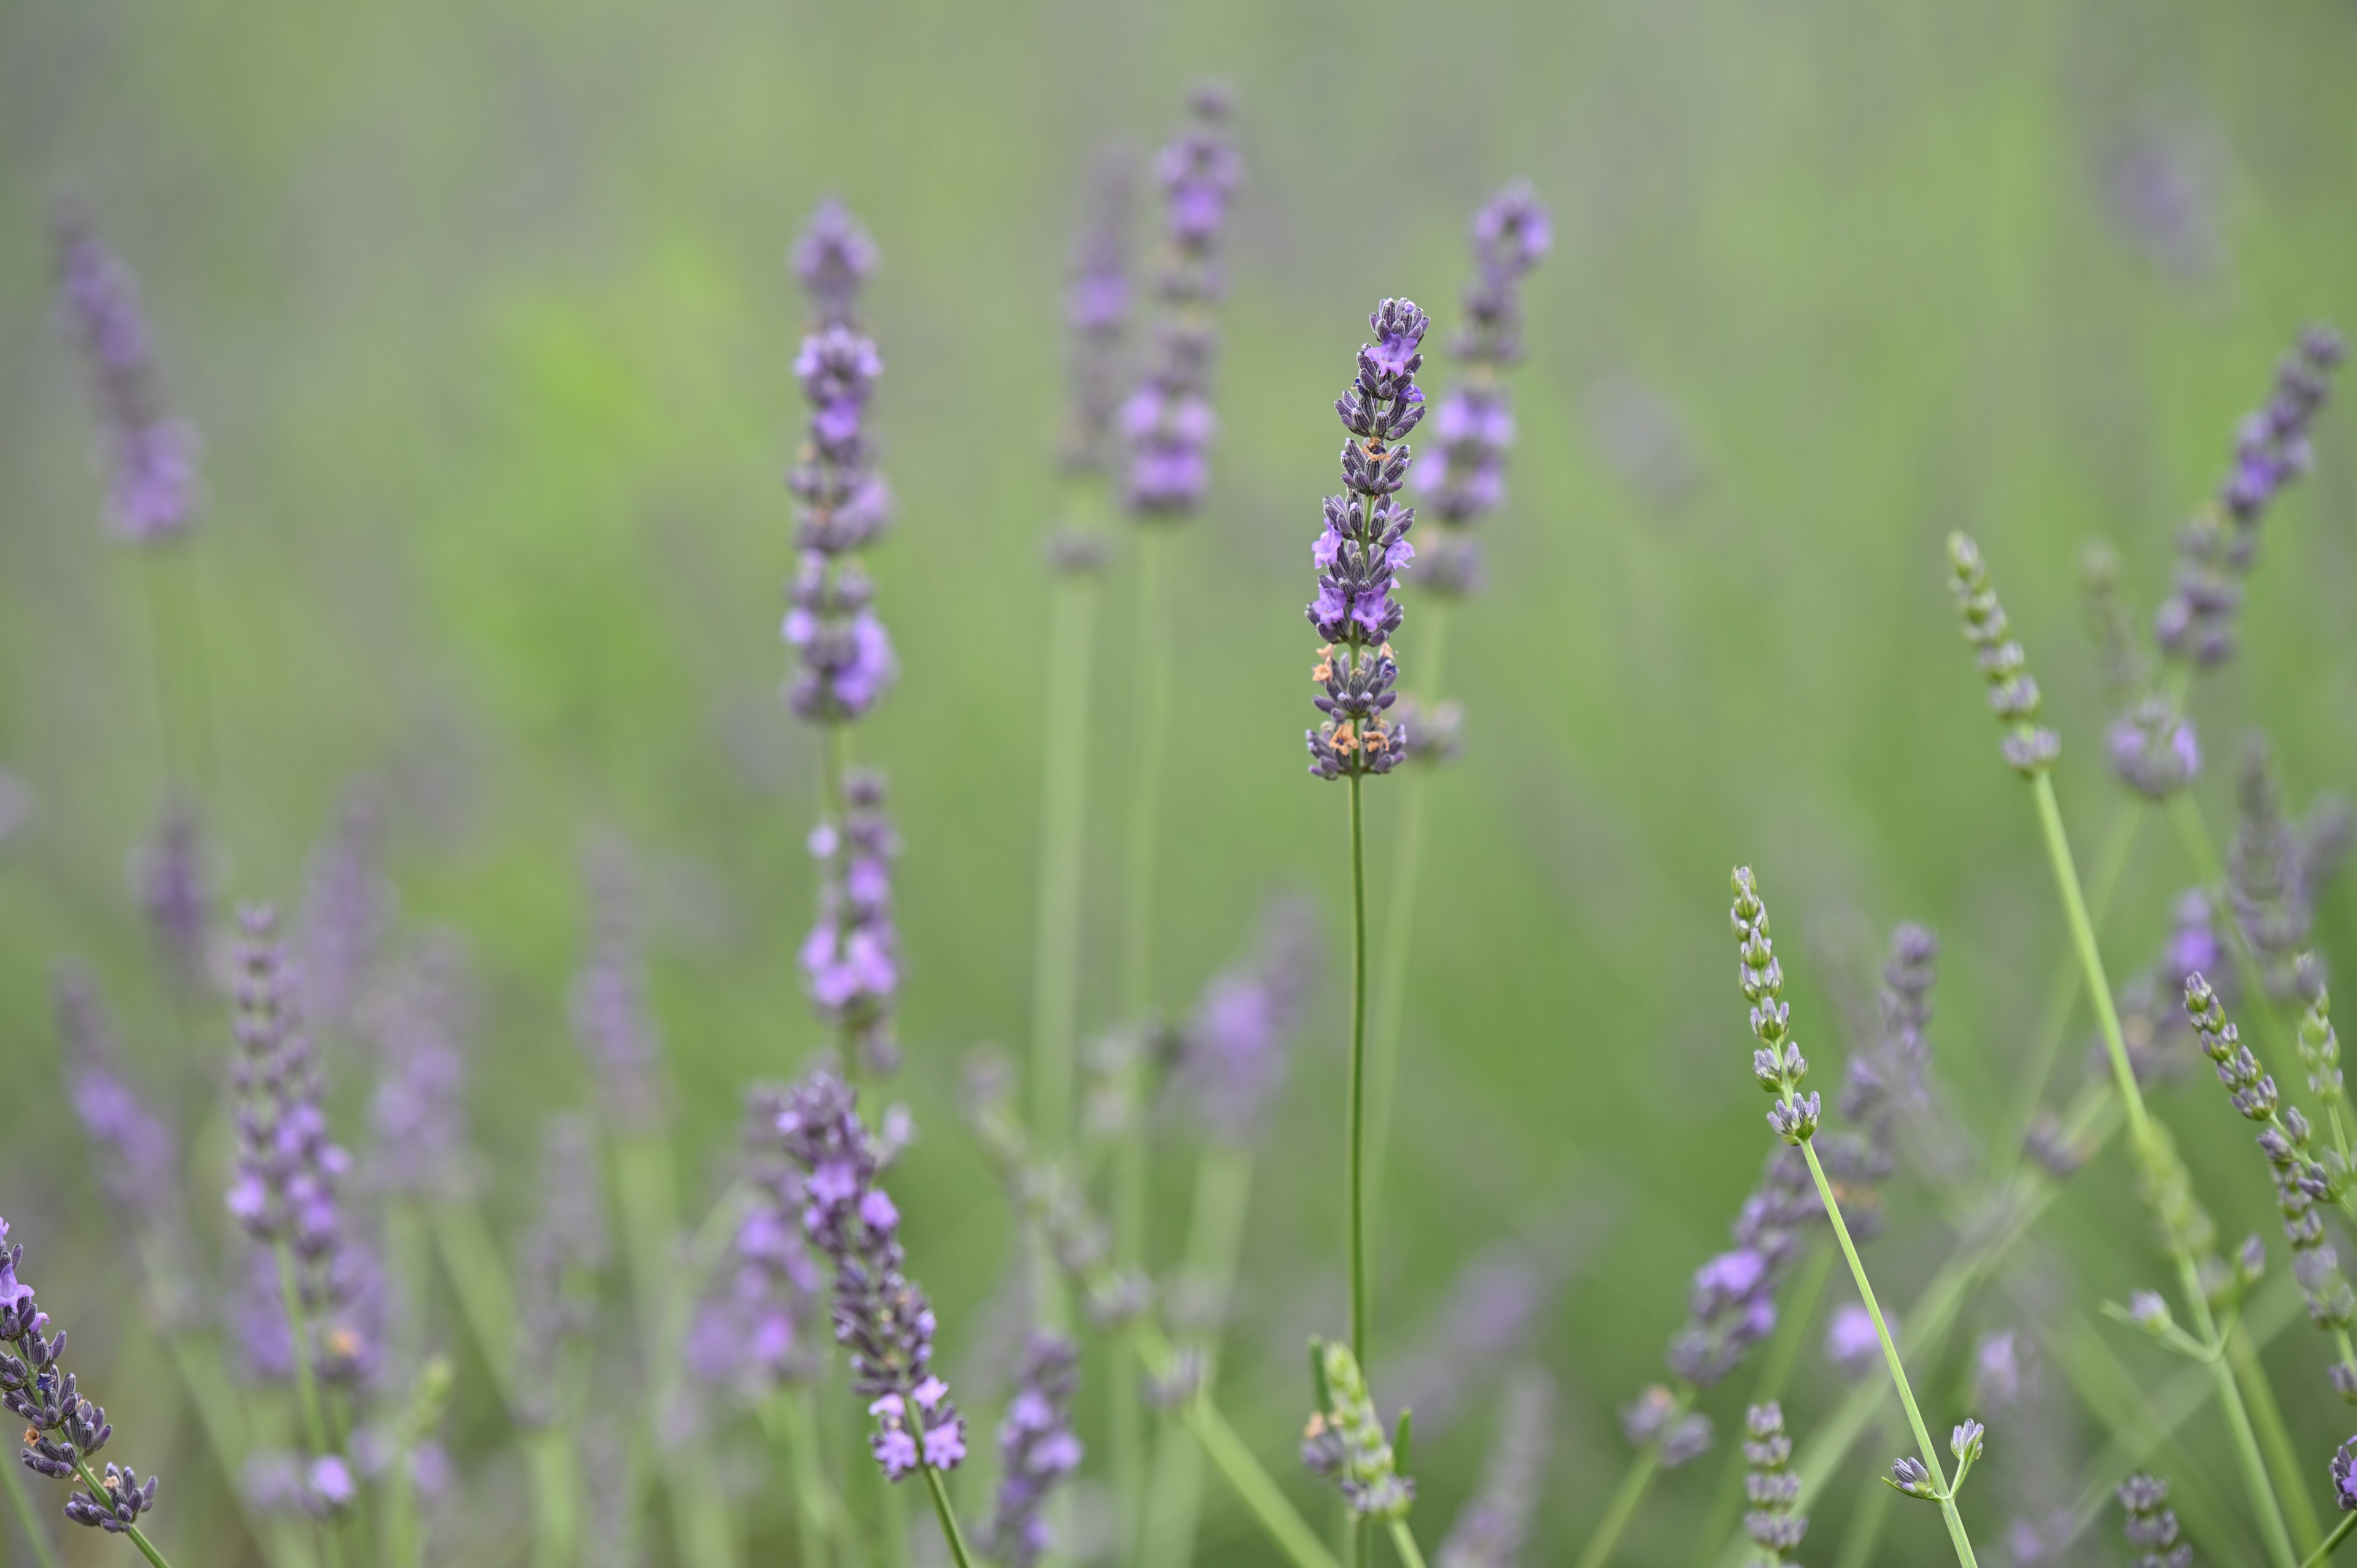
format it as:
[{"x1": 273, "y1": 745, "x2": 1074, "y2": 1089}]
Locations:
[{"x1": 785, "y1": 203, "x2": 896, "y2": 724}]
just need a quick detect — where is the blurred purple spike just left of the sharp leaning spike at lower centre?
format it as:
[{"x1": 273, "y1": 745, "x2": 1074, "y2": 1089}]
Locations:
[{"x1": 688, "y1": 1087, "x2": 825, "y2": 1400}]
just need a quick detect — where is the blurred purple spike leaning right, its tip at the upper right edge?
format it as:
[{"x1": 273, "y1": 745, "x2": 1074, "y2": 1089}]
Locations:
[{"x1": 2152, "y1": 325, "x2": 2343, "y2": 667}]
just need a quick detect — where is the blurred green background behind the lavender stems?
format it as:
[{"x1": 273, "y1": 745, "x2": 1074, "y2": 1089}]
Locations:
[{"x1": 0, "y1": 0, "x2": 2357, "y2": 1568}]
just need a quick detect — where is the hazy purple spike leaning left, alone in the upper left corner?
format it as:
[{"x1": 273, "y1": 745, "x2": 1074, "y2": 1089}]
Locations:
[{"x1": 54, "y1": 203, "x2": 198, "y2": 545}]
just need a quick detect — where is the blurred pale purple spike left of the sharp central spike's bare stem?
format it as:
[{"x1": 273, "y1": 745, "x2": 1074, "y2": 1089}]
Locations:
[{"x1": 1176, "y1": 901, "x2": 1320, "y2": 1146}]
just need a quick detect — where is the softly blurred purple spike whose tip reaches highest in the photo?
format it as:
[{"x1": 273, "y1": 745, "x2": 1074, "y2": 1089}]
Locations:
[{"x1": 1120, "y1": 85, "x2": 1242, "y2": 519}]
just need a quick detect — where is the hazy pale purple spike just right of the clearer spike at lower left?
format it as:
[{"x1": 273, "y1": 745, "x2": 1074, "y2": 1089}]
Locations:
[{"x1": 368, "y1": 933, "x2": 471, "y2": 1200}]
